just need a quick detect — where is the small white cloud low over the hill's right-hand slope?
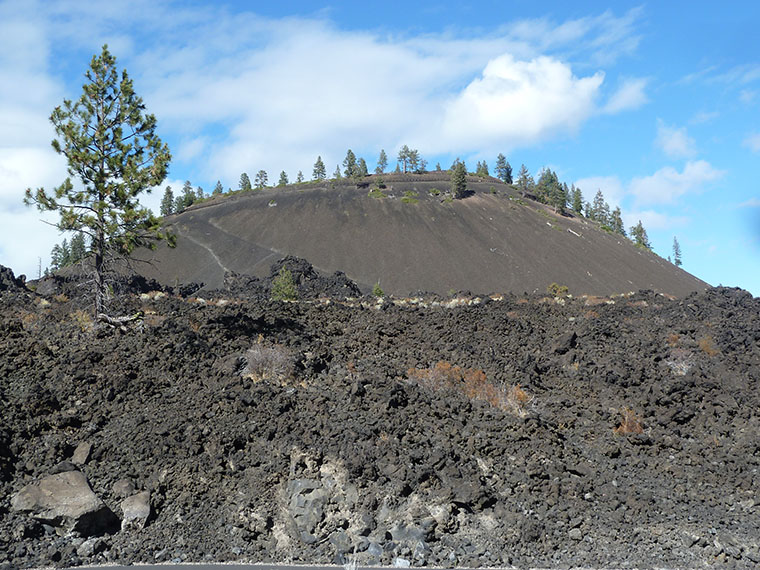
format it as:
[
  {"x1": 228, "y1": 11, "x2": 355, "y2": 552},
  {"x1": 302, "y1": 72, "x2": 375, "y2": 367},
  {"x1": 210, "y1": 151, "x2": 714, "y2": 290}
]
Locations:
[{"x1": 629, "y1": 160, "x2": 724, "y2": 204}]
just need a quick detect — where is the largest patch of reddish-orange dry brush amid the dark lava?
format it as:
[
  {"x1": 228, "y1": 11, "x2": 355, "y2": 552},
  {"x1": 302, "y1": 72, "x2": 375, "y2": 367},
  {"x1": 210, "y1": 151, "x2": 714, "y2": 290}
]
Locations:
[{"x1": 407, "y1": 360, "x2": 533, "y2": 417}]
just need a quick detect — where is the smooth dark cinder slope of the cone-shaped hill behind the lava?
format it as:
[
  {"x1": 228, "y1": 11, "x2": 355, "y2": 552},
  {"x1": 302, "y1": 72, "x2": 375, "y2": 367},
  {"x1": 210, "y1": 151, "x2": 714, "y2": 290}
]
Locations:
[{"x1": 135, "y1": 173, "x2": 707, "y2": 297}]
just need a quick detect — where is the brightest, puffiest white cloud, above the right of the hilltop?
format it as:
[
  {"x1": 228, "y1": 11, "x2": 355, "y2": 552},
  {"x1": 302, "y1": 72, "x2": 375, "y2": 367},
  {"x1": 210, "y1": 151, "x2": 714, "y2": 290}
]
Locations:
[{"x1": 436, "y1": 54, "x2": 604, "y2": 152}]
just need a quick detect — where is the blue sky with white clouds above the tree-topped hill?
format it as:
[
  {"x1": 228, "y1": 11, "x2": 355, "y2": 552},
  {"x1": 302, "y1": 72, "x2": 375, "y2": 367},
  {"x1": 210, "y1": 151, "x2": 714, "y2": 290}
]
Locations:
[{"x1": 0, "y1": 0, "x2": 760, "y2": 296}]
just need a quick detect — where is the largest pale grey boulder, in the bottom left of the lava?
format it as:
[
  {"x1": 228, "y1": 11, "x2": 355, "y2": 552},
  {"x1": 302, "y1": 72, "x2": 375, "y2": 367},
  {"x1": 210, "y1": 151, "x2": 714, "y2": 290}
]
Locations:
[{"x1": 11, "y1": 471, "x2": 118, "y2": 536}]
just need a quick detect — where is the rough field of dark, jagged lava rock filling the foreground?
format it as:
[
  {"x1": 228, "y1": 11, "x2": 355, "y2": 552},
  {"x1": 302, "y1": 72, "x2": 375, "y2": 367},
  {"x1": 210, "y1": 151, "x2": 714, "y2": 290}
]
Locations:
[{"x1": 0, "y1": 267, "x2": 760, "y2": 569}]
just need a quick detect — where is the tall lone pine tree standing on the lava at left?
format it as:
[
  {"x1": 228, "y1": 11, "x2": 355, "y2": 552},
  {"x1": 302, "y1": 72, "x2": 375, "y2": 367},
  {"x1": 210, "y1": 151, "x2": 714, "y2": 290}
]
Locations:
[{"x1": 24, "y1": 45, "x2": 172, "y2": 318}]
